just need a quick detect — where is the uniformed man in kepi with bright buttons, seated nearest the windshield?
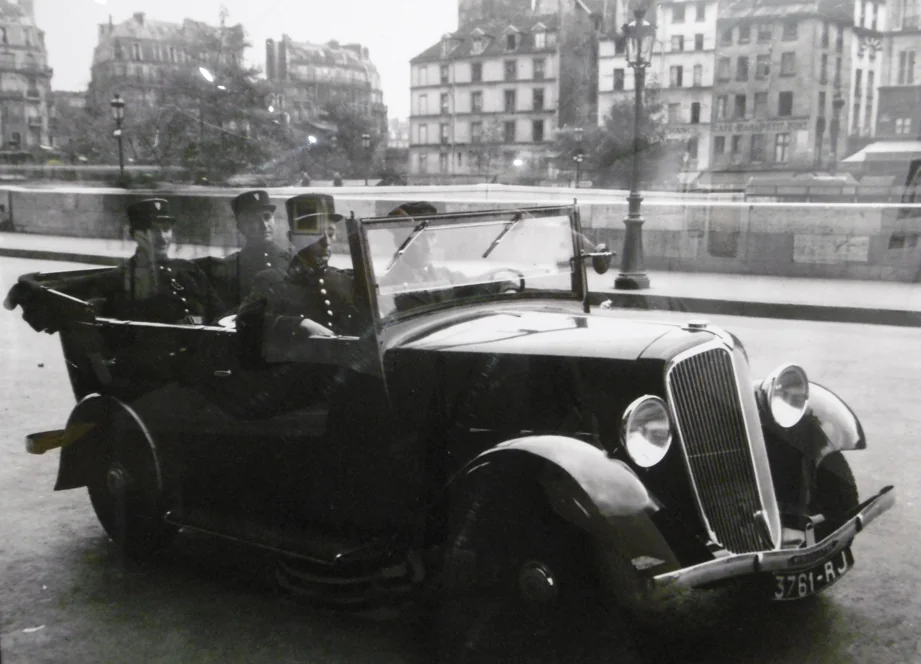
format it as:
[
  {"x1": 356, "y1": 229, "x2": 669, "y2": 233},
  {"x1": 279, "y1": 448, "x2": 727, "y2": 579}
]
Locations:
[{"x1": 236, "y1": 194, "x2": 361, "y2": 358}]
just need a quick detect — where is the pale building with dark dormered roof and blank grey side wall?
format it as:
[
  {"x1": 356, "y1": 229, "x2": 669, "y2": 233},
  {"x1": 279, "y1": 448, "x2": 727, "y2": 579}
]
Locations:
[{"x1": 410, "y1": 0, "x2": 603, "y2": 182}]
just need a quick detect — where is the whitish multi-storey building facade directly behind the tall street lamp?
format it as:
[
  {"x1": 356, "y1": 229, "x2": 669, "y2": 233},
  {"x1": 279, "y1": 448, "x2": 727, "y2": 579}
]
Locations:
[{"x1": 598, "y1": 0, "x2": 719, "y2": 180}]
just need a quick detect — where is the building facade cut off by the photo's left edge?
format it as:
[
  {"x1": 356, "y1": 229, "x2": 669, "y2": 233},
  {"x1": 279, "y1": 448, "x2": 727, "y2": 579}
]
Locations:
[{"x1": 0, "y1": 0, "x2": 53, "y2": 155}]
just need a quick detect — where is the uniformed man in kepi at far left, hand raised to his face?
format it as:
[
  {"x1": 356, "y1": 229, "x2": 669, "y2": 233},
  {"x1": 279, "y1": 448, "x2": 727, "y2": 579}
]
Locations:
[{"x1": 84, "y1": 198, "x2": 225, "y2": 324}]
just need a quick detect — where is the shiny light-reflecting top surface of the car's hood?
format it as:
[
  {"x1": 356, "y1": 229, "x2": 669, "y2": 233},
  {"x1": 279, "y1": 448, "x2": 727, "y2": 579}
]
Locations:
[{"x1": 398, "y1": 310, "x2": 685, "y2": 360}]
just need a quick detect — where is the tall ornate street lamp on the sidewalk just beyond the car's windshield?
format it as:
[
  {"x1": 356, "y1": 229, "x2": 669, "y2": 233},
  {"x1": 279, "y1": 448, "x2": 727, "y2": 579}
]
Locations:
[{"x1": 614, "y1": 9, "x2": 656, "y2": 290}]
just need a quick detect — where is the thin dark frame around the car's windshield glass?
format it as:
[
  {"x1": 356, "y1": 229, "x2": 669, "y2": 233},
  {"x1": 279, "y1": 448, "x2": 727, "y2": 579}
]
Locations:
[{"x1": 350, "y1": 203, "x2": 588, "y2": 331}]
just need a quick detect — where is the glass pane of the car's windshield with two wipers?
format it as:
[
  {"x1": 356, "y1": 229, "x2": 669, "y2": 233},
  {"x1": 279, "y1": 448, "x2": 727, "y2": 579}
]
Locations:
[{"x1": 367, "y1": 211, "x2": 573, "y2": 318}]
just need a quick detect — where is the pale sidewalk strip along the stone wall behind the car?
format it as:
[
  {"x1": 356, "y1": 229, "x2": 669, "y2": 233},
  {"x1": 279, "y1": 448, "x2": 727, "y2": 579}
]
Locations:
[{"x1": 0, "y1": 233, "x2": 921, "y2": 327}]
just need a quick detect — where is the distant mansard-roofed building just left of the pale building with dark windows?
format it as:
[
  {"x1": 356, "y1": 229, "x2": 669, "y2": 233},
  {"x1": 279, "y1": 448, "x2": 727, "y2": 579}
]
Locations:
[{"x1": 265, "y1": 35, "x2": 388, "y2": 142}]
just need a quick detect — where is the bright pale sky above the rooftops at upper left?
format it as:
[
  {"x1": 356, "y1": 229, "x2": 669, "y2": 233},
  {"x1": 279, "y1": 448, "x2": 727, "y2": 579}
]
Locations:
[{"x1": 34, "y1": 0, "x2": 457, "y2": 119}]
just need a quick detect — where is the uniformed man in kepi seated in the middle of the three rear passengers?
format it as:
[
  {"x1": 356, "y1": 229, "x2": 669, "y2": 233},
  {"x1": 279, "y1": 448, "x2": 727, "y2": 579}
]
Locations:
[{"x1": 219, "y1": 190, "x2": 292, "y2": 306}]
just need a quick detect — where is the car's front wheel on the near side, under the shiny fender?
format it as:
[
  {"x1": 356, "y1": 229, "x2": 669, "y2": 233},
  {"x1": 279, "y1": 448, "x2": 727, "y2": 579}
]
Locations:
[{"x1": 435, "y1": 474, "x2": 623, "y2": 663}]
